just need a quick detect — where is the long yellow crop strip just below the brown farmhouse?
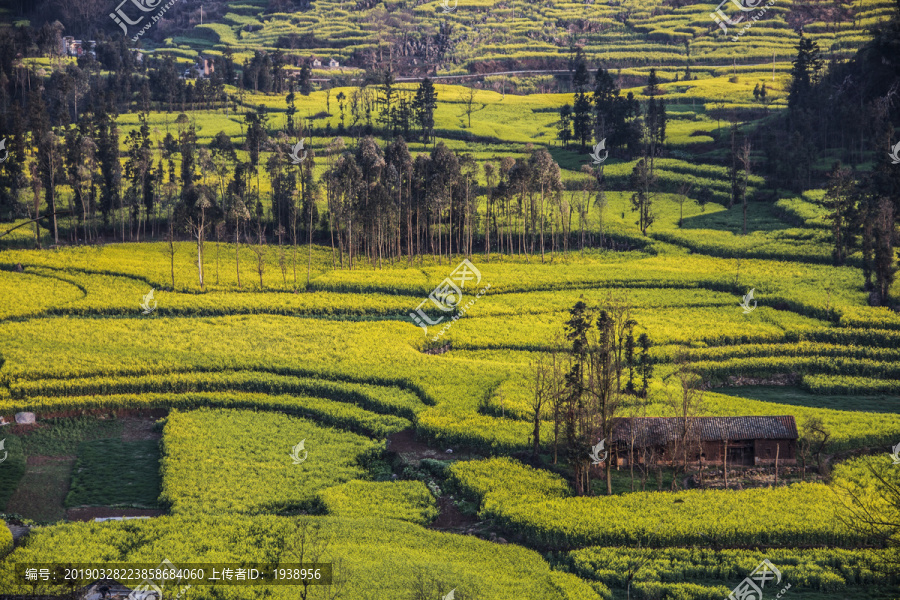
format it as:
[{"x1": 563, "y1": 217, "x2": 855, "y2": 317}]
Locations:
[{"x1": 451, "y1": 459, "x2": 868, "y2": 549}]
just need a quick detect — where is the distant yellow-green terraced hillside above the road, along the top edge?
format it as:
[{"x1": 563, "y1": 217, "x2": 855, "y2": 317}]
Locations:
[{"x1": 151, "y1": 0, "x2": 891, "y2": 74}]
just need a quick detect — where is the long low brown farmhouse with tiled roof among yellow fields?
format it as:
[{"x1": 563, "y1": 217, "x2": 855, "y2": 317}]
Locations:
[{"x1": 610, "y1": 415, "x2": 798, "y2": 466}]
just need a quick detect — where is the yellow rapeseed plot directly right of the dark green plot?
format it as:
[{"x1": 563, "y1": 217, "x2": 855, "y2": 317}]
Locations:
[{"x1": 160, "y1": 409, "x2": 384, "y2": 514}]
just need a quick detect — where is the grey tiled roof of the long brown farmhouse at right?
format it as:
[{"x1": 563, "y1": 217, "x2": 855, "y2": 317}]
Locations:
[{"x1": 612, "y1": 415, "x2": 798, "y2": 446}]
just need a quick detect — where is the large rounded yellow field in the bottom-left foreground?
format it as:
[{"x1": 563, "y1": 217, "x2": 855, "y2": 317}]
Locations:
[{"x1": 0, "y1": 515, "x2": 603, "y2": 600}]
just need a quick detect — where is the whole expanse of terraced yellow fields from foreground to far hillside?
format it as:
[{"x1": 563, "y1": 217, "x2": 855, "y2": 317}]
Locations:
[{"x1": 0, "y1": 0, "x2": 900, "y2": 600}]
